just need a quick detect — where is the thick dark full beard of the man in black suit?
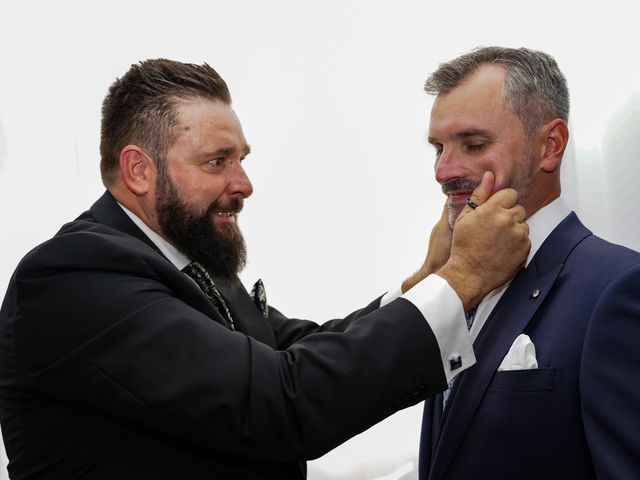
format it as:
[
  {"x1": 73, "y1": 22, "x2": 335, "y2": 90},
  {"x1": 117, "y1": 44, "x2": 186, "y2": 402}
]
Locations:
[{"x1": 156, "y1": 171, "x2": 247, "y2": 283}]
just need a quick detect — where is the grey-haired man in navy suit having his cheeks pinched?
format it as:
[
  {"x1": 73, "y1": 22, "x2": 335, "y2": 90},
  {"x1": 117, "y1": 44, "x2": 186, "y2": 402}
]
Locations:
[{"x1": 420, "y1": 47, "x2": 640, "y2": 480}]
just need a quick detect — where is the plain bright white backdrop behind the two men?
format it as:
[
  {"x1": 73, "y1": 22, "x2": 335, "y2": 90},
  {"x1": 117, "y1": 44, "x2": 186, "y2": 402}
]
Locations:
[{"x1": 0, "y1": 0, "x2": 640, "y2": 480}]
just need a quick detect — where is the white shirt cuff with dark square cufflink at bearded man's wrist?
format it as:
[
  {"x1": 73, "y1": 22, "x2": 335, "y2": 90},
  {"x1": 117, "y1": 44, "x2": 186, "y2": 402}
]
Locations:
[{"x1": 404, "y1": 275, "x2": 476, "y2": 381}]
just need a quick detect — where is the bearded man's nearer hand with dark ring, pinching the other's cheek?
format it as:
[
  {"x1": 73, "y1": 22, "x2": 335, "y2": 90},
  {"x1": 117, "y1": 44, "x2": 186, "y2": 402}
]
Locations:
[{"x1": 436, "y1": 172, "x2": 531, "y2": 311}]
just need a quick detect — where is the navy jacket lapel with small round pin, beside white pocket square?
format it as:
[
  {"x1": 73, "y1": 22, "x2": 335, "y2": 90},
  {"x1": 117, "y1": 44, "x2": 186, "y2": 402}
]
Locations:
[{"x1": 429, "y1": 213, "x2": 591, "y2": 480}]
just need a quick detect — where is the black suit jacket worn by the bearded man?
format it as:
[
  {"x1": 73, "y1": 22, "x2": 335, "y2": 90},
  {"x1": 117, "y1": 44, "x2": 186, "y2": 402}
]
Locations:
[{"x1": 0, "y1": 193, "x2": 446, "y2": 480}]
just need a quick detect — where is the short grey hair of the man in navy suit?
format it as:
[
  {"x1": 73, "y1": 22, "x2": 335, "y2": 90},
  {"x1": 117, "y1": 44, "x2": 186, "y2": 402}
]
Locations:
[{"x1": 424, "y1": 47, "x2": 569, "y2": 139}]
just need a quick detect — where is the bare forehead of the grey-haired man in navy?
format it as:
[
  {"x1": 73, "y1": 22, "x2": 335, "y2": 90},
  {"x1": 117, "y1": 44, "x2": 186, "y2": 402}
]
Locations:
[{"x1": 429, "y1": 65, "x2": 515, "y2": 136}]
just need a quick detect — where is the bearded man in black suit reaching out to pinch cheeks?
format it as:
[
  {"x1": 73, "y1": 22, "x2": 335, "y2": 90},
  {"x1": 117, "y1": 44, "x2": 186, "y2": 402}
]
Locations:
[{"x1": 0, "y1": 59, "x2": 529, "y2": 480}]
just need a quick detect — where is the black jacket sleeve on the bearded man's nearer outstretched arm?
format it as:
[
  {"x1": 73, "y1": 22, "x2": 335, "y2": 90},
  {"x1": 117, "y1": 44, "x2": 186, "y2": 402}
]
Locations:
[{"x1": 10, "y1": 231, "x2": 446, "y2": 460}]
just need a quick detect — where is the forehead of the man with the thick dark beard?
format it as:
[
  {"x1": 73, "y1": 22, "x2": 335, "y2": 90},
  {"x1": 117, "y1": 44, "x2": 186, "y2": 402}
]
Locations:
[{"x1": 174, "y1": 98, "x2": 248, "y2": 155}]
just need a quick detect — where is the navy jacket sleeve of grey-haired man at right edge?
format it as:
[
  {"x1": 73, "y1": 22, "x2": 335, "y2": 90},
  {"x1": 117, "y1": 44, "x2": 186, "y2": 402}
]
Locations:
[{"x1": 580, "y1": 265, "x2": 640, "y2": 479}]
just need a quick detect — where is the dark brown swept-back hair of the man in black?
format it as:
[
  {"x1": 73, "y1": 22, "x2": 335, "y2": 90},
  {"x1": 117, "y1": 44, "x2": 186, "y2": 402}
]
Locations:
[{"x1": 100, "y1": 58, "x2": 231, "y2": 187}]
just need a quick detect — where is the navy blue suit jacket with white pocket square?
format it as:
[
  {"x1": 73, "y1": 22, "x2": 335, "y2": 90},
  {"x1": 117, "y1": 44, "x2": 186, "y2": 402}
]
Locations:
[{"x1": 420, "y1": 213, "x2": 640, "y2": 480}]
